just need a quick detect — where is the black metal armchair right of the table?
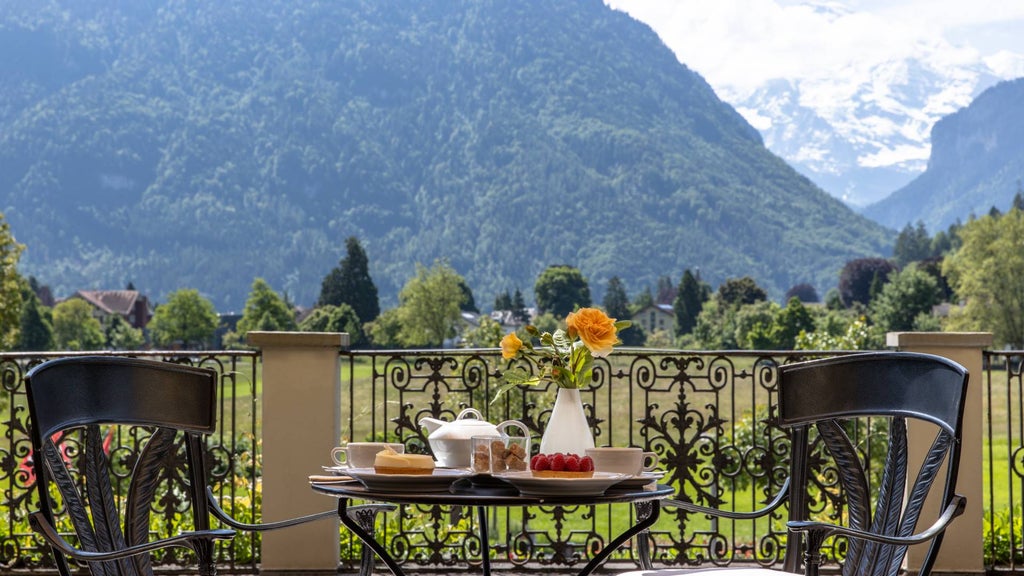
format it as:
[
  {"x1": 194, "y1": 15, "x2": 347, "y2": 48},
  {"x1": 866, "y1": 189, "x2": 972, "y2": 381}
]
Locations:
[{"x1": 620, "y1": 353, "x2": 968, "y2": 576}]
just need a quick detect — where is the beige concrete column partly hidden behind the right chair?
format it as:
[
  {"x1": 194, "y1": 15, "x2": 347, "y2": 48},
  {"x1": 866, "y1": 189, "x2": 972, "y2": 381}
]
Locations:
[{"x1": 886, "y1": 332, "x2": 992, "y2": 574}]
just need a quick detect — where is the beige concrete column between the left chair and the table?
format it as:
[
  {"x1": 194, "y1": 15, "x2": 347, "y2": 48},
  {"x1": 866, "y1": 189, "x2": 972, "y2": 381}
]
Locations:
[{"x1": 247, "y1": 332, "x2": 348, "y2": 574}]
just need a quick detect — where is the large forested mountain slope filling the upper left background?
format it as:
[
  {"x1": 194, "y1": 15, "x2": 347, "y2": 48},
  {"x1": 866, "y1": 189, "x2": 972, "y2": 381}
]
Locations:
[{"x1": 0, "y1": 0, "x2": 890, "y2": 312}]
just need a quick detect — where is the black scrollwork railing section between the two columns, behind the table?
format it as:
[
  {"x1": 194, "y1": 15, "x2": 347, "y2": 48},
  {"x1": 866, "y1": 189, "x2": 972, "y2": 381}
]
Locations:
[{"x1": 342, "y1": 348, "x2": 856, "y2": 566}]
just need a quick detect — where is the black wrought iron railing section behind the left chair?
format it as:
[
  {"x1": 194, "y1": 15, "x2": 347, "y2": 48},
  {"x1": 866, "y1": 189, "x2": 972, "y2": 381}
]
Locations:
[{"x1": 0, "y1": 352, "x2": 259, "y2": 573}]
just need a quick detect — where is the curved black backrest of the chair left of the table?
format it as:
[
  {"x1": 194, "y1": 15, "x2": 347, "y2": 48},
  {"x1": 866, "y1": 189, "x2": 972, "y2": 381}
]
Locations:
[{"x1": 26, "y1": 357, "x2": 217, "y2": 576}]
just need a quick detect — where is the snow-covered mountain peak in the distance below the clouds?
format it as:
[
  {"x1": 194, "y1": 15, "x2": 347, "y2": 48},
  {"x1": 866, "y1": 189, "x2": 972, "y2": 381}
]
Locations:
[{"x1": 719, "y1": 59, "x2": 998, "y2": 207}]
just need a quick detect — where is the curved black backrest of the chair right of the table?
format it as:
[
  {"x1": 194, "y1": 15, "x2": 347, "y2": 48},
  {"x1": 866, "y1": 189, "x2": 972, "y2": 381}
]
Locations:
[{"x1": 777, "y1": 352, "x2": 968, "y2": 576}]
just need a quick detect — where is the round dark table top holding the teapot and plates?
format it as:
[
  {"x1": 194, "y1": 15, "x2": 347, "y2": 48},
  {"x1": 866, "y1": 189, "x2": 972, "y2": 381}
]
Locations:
[{"x1": 310, "y1": 479, "x2": 676, "y2": 506}]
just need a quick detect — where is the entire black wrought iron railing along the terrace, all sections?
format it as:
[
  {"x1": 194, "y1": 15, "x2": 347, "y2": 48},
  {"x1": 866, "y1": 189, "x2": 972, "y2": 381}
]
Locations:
[{"x1": 0, "y1": 342, "x2": 1011, "y2": 573}]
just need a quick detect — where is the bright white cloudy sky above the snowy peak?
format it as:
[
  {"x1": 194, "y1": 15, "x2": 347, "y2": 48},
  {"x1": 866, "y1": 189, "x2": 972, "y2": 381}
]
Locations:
[{"x1": 605, "y1": 0, "x2": 1024, "y2": 97}]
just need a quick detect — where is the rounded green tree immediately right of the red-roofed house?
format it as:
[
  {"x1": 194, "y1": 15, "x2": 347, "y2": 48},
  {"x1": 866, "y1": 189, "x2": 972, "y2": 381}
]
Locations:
[{"x1": 148, "y1": 288, "x2": 218, "y2": 349}]
